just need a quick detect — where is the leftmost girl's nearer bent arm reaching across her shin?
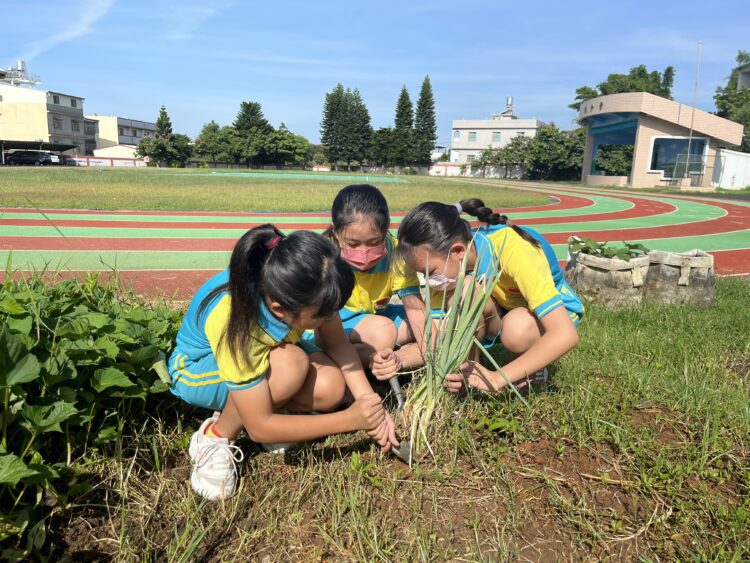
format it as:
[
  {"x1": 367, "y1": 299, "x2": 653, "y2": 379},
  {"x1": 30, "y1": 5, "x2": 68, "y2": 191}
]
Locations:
[{"x1": 231, "y1": 379, "x2": 385, "y2": 443}]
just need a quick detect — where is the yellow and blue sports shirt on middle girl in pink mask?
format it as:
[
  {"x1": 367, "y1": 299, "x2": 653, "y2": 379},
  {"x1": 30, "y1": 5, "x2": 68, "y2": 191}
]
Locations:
[{"x1": 340, "y1": 233, "x2": 421, "y2": 321}]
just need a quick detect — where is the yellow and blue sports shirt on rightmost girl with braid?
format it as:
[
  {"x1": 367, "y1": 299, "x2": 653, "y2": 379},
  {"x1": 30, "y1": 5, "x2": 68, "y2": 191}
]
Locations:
[{"x1": 473, "y1": 225, "x2": 583, "y2": 322}]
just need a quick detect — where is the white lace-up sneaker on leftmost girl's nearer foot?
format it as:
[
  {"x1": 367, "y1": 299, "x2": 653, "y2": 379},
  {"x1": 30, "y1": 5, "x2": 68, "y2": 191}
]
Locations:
[{"x1": 188, "y1": 413, "x2": 245, "y2": 500}]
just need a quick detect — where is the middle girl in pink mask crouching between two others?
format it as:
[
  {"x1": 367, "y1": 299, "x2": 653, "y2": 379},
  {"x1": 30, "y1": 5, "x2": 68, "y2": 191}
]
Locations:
[{"x1": 316, "y1": 184, "x2": 432, "y2": 380}]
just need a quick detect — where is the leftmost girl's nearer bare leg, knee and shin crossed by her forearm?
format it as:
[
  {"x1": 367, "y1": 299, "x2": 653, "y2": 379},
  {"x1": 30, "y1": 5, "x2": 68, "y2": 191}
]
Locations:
[{"x1": 213, "y1": 344, "x2": 310, "y2": 441}]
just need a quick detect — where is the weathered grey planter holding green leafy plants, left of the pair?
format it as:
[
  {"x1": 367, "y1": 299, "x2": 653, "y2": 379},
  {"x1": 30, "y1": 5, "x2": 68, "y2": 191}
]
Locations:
[{"x1": 565, "y1": 252, "x2": 649, "y2": 309}]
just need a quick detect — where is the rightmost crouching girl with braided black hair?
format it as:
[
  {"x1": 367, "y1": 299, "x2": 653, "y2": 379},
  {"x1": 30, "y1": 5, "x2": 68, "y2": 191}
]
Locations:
[{"x1": 398, "y1": 199, "x2": 583, "y2": 393}]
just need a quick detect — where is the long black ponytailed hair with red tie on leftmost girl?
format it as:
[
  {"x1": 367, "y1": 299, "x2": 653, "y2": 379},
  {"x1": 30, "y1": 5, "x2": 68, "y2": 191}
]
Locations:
[{"x1": 199, "y1": 224, "x2": 354, "y2": 370}]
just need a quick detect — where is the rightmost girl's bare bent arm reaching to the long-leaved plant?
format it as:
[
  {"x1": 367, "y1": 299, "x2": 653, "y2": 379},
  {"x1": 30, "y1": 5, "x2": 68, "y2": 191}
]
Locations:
[{"x1": 446, "y1": 307, "x2": 578, "y2": 392}]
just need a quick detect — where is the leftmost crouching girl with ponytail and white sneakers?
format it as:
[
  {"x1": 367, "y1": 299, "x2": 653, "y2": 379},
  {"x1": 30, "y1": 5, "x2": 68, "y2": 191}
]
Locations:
[{"x1": 169, "y1": 225, "x2": 398, "y2": 500}]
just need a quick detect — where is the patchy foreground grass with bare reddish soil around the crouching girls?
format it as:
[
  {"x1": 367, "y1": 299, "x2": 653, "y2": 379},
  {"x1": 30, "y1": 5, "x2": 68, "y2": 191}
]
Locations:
[{"x1": 41, "y1": 279, "x2": 750, "y2": 561}]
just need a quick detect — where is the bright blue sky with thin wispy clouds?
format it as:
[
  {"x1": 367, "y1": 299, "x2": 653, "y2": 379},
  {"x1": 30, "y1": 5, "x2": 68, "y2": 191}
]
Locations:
[{"x1": 0, "y1": 0, "x2": 750, "y2": 143}]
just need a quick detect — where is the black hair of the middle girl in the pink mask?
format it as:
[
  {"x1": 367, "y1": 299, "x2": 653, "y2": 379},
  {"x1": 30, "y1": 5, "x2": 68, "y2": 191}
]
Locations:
[{"x1": 323, "y1": 184, "x2": 391, "y2": 240}]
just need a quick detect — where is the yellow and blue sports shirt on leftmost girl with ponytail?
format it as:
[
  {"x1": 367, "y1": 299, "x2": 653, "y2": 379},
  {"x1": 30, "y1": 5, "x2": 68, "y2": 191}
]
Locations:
[{"x1": 169, "y1": 270, "x2": 300, "y2": 390}]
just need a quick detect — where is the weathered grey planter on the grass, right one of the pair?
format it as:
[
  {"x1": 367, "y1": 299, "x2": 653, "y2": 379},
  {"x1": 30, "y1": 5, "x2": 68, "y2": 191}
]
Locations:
[{"x1": 643, "y1": 250, "x2": 716, "y2": 307}]
